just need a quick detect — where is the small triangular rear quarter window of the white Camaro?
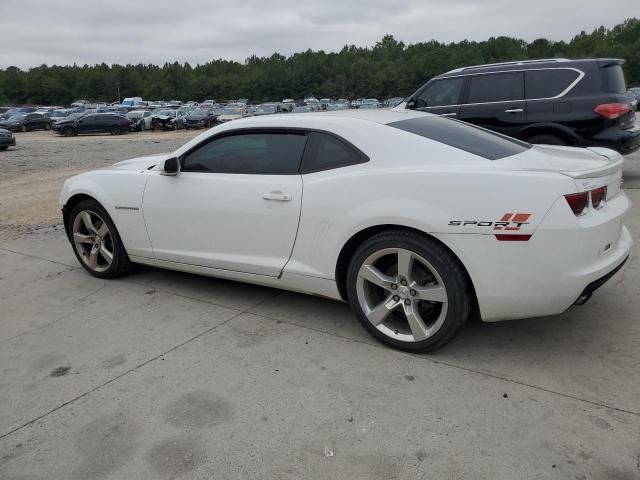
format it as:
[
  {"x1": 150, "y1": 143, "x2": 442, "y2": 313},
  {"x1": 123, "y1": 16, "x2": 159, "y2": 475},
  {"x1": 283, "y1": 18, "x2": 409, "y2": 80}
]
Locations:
[{"x1": 301, "y1": 132, "x2": 369, "y2": 173}]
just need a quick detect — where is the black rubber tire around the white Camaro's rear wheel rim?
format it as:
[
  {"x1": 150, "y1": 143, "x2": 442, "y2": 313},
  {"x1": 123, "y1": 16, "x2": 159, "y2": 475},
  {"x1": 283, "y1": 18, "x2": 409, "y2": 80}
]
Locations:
[{"x1": 347, "y1": 230, "x2": 474, "y2": 353}]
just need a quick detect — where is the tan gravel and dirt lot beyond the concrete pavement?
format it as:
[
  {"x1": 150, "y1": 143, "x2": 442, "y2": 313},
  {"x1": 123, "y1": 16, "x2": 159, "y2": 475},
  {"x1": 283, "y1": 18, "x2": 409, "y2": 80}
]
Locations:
[{"x1": 0, "y1": 130, "x2": 640, "y2": 240}]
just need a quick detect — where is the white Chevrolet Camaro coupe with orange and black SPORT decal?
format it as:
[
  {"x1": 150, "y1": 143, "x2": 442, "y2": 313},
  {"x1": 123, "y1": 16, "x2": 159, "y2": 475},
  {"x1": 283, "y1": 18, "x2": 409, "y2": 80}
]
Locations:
[{"x1": 60, "y1": 110, "x2": 632, "y2": 352}]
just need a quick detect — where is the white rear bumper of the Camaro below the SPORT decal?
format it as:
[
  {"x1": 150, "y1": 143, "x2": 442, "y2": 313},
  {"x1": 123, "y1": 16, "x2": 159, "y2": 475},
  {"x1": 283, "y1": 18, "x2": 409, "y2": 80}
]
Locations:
[{"x1": 441, "y1": 192, "x2": 633, "y2": 322}]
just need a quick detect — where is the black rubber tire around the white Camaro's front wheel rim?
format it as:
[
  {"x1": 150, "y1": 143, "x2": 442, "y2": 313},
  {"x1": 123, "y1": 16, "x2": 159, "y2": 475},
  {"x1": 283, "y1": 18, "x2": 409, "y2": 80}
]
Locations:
[{"x1": 66, "y1": 199, "x2": 132, "y2": 279}]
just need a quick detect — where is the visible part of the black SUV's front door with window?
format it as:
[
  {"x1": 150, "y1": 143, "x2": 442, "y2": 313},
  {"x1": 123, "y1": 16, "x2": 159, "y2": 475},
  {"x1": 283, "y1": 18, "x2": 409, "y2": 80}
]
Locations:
[{"x1": 407, "y1": 77, "x2": 465, "y2": 118}]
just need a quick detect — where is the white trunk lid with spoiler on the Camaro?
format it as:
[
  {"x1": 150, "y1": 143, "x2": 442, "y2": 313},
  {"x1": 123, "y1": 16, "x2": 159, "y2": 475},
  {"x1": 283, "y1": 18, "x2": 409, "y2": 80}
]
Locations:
[{"x1": 495, "y1": 145, "x2": 623, "y2": 178}]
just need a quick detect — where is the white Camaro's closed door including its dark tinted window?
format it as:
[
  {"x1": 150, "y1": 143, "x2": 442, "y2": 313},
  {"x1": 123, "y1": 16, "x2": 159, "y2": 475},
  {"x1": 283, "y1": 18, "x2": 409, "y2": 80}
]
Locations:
[{"x1": 143, "y1": 129, "x2": 307, "y2": 276}]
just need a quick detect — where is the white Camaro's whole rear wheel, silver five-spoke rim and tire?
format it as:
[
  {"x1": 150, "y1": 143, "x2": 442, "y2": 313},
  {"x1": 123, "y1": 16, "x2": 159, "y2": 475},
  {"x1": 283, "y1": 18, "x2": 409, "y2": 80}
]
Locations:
[{"x1": 347, "y1": 231, "x2": 472, "y2": 352}]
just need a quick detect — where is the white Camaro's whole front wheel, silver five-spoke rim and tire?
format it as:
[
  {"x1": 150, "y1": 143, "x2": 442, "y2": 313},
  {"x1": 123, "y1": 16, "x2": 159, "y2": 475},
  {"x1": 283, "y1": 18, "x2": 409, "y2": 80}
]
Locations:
[{"x1": 69, "y1": 200, "x2": 131, "y2": 278}]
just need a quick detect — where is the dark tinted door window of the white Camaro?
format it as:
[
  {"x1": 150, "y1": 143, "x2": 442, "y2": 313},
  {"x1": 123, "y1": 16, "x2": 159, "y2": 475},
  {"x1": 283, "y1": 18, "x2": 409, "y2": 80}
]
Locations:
[{"x1": 182, "y1": 132, "x2": 307, "y2": 175}]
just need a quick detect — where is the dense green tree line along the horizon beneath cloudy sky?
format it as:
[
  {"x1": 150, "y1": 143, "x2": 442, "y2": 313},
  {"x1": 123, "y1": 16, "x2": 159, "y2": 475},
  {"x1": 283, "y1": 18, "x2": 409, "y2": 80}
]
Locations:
[{"x1": 0, "y1": 18, "x2": 640, "y2": 105}]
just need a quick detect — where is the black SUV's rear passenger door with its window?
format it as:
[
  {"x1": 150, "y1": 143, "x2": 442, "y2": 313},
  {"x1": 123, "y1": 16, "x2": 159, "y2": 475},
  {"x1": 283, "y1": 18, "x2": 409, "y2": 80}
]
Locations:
[{"x1": 458, "y1": 71, "x2": 527, "y2": 135}]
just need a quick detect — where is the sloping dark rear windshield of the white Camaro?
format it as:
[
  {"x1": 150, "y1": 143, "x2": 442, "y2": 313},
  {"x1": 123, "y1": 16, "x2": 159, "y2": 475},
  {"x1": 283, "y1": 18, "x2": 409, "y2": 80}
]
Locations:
[{"x1": 388, "y1": 115, "x2": 531, "y2": 160}]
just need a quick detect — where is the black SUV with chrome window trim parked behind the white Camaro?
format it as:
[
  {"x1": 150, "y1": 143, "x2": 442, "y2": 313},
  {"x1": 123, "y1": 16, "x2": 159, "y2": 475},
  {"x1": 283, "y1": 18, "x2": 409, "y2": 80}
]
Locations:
[{"x1": 404, "y1": 58, "x2": 640, "y2": 154}]
